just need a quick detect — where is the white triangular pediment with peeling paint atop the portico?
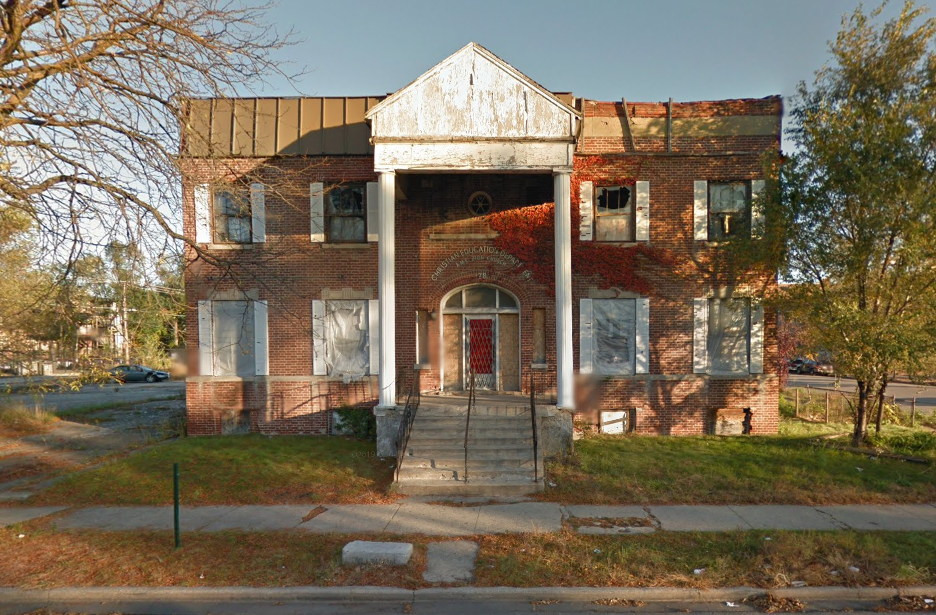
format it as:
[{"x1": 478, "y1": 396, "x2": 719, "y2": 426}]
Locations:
[{"x1": 367, "y1": 43, "x2": 579, "y2": 143}]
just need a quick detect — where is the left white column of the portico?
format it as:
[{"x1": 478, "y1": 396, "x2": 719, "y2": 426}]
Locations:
[{"x1": 377, "y1": 171, "x2": 396, "y2": 408}]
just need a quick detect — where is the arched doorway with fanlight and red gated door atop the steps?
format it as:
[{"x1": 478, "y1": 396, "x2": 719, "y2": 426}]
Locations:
[{"x1": 440, "y1": 284, "x2": 520, "y2": 391}]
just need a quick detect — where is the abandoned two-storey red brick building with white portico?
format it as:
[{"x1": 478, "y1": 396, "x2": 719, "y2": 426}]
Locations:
[{"x1": 180, "y1": 44, "x2": 782, "y2": 490}]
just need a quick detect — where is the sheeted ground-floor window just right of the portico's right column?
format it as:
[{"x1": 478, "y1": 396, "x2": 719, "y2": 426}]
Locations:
[{"x1": 592, "y1": 299, "x2": 637, "y2": 376}]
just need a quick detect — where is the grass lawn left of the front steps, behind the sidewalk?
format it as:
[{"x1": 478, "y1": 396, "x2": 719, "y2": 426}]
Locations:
[{"x1": 30, "y1": 434, "x2": 395, "y2": 506}]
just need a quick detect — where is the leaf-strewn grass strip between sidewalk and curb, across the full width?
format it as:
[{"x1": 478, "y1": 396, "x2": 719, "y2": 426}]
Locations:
[{"x1": 0, "y1": 520, "x2": 936, "y2": 589}]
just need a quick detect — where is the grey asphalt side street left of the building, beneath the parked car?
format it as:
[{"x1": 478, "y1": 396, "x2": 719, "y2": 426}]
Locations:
[{"x1": 5, "y1": 380, "x2": 185, "y2": 412}]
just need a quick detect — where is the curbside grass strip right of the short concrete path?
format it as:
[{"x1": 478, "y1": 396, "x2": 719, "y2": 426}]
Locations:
[{"x1": 476, "y1": 531, "x2": 936, "y2": 588}]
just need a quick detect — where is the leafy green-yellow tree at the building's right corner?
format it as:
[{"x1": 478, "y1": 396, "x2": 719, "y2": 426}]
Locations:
[{"x1": 751, "y1": 1, "x2": 936, "y2": 444}]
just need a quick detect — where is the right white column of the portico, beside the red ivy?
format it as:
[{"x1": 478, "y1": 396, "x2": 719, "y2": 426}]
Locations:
[{"x1": 553, "y1": 172, "x2": 575, "y2": 410}]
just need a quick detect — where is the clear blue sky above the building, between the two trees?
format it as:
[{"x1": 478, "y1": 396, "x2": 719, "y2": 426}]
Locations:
[{"x1": 258, "y1": 0, "x2": 923, "y2": 107}]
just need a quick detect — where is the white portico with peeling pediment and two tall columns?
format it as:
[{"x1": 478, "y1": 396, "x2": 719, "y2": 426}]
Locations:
[{"x1": 366, "y1": 43, "x2": 581, "y2": 418}]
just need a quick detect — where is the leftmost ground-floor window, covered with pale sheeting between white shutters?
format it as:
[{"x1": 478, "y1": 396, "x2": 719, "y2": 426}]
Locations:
[{"x1": 211, "y1": 301, "x2": 256, "y2": 377}]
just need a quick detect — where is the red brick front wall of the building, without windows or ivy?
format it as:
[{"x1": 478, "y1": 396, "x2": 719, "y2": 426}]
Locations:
[{"x1": 182, "y1": 99, "x2": 779, "y2": 434}]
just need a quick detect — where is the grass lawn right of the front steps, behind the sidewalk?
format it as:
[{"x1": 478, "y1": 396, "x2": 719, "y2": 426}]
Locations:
[{"x1": 542, "y1": 436, "x2": 936, "y2": 504}]
